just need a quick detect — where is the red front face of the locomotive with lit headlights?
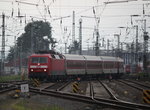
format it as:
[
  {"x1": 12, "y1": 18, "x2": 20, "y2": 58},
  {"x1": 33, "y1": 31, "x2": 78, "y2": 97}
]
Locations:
[{"x1": 28, "y1": 54, "x2": 50, "y2": 79}]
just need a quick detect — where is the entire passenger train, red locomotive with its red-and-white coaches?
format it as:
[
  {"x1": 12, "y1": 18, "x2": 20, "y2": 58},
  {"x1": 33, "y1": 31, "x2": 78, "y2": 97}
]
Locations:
[{"x1": 28, "y1": 51, "x2": 124, "y2": 80}]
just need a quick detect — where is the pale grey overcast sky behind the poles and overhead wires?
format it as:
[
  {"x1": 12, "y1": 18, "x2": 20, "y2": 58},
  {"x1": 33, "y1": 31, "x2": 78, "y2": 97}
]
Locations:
[{"x1": 0, "y1": 0, "x2": 150, "y2": 52}]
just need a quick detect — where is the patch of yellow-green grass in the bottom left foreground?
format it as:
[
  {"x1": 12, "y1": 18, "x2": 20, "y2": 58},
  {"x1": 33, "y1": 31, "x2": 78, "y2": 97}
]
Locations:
[{"x1": 0, "y1": 99, "x2": 64, "y2": 110}]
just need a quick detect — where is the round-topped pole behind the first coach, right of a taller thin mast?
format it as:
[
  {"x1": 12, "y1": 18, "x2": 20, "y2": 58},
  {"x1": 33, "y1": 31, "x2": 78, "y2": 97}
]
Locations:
[{"x1": 79, "y1": 19, "x2": 82, "y2": 55}]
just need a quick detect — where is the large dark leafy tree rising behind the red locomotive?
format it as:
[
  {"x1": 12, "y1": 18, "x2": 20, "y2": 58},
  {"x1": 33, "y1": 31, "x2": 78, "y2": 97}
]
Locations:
[{"x1": 7, "y1": 21, "x2": 56, "y2": 61}]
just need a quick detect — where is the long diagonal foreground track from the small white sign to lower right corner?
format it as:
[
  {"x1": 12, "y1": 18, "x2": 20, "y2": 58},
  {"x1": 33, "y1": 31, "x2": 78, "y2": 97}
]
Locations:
[{"x1": 30, "y1": 80, "x2": 150, "y2": 110}]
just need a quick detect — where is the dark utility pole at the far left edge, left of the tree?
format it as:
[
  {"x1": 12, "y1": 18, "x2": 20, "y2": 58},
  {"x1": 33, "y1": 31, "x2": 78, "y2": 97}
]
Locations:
[{"x1": 1, "y1": 13, "x2": 5, "y2": 73}]
